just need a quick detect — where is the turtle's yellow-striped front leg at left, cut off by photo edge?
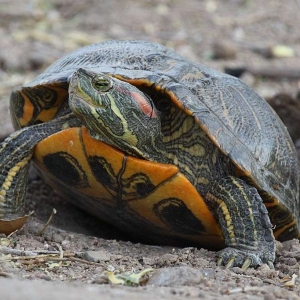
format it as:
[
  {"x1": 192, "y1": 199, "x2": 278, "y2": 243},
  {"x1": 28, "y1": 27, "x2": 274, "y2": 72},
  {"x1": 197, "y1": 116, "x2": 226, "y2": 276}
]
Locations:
[{"x1": 0, "y1": 114, "x2": 81, "y2": 219}]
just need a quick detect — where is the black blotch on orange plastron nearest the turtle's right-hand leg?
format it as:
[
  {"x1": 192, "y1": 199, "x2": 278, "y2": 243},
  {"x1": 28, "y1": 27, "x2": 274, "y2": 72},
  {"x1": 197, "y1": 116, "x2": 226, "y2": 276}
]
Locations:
[{"x1": 153, "y1": 198, "x2": 205, "y2": 235}]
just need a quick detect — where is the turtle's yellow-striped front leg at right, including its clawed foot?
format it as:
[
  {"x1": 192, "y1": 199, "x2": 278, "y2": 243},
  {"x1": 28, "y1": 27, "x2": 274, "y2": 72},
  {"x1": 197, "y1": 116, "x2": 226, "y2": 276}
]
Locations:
[{"x1": 206, "y1": 176, "x2": 275, "y2": 269}]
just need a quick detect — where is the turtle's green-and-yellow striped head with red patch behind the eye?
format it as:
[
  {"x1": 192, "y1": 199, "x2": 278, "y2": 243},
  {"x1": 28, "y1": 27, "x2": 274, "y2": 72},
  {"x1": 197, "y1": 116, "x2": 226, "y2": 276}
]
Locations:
[{"x1": 69, "y1": 69, "x2": 162, "y2": 161}]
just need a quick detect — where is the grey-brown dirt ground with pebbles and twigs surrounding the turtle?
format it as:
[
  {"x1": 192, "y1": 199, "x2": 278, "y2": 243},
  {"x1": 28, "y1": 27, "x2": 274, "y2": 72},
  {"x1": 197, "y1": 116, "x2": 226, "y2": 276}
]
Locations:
[{"x1": 0, "y1": 0, "x2": 300, "y2": 300}]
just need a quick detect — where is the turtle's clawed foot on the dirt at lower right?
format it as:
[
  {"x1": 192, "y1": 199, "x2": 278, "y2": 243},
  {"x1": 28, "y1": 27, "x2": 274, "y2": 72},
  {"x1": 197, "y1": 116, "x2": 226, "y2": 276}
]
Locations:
[{"x1": 218, "y1": 247, "x2": 275, "y2": 271}]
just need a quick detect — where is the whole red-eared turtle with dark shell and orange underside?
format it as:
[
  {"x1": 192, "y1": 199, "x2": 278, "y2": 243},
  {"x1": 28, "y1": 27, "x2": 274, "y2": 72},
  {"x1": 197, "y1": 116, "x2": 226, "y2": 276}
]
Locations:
[{"x1": 0, "y1": 40, "x2": 299, "y2": 269}]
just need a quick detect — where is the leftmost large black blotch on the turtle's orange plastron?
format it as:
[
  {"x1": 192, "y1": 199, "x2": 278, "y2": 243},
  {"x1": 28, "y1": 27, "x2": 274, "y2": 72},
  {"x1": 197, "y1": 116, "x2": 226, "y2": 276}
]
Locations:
[{"x1": 43, "y1": 151, "x2": 89, "y2": 187}]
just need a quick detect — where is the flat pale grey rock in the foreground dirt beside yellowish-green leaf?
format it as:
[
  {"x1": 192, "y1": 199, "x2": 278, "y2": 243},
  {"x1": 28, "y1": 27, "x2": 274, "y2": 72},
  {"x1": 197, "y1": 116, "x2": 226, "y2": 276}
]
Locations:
[{"x1": 147, "y1": 267, "x2": 215, "y2": 287}]
